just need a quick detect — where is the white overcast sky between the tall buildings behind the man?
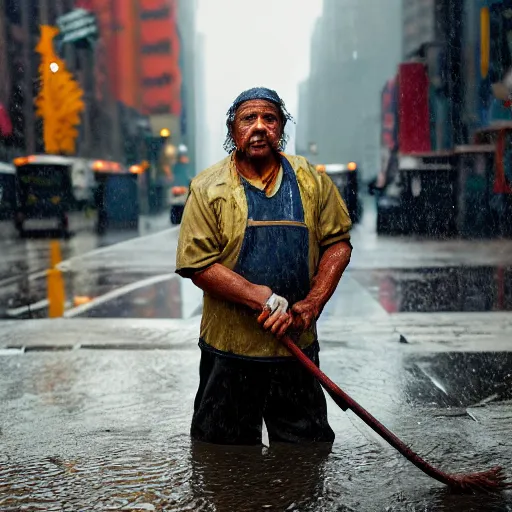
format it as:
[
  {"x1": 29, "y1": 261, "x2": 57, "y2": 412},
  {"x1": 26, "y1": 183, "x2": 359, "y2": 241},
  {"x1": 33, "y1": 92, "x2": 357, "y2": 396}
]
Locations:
[{"x1": 194, "y1": 0, "x2": 323, "y2": 163}]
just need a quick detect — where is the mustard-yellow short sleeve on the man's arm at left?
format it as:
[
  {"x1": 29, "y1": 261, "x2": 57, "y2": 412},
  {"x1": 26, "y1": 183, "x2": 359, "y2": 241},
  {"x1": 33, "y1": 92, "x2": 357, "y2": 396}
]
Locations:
[{"x1": 176, "y1": 182, "x2": 221, "y2": 277}]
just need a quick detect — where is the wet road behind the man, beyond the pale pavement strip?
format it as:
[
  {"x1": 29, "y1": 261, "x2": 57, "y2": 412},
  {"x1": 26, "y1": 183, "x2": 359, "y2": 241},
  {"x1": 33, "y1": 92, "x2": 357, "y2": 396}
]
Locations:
[{"x1": 5, "y1": 220, "x2": 512, "y2": 319}]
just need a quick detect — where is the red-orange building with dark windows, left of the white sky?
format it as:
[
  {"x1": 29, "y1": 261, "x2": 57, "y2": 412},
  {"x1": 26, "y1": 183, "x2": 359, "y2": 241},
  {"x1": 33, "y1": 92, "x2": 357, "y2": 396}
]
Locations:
[{"x1": 80, "y1": 0, "x2": 202, "y2": 169}]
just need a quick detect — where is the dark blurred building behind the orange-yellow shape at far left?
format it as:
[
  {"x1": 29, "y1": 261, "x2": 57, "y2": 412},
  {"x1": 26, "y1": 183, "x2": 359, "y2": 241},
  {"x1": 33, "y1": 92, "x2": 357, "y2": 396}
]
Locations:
[{"x1": 0, "y1": 0, "x2": 116, "y2": 160}]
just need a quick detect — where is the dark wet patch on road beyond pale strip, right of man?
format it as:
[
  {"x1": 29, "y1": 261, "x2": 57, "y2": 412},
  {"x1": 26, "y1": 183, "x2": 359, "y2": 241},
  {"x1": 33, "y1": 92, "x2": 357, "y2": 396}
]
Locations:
[{"x1": 350, "y1": 267, "x2": 512, "y2": 313}]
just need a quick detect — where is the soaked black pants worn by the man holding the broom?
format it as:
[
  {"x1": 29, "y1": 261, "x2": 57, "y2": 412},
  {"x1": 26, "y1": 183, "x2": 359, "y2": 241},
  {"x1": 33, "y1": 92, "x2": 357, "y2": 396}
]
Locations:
[{"x1": 190, "y1": 350, "x2": 334, "y2": 445}]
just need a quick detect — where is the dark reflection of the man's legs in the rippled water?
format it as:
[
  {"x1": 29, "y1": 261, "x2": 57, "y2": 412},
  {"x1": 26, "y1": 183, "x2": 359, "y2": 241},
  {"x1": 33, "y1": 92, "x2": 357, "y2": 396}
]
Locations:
[{"x1": 191, "y1": 442, "x2": 330, "y2": 512}]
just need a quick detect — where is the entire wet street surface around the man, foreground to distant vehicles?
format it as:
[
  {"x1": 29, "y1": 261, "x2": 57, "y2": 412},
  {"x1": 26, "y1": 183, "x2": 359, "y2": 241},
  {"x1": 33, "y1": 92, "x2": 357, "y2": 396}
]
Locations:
[{"x1": 0, "y1": 204, "x2": 512, "y2": 512}]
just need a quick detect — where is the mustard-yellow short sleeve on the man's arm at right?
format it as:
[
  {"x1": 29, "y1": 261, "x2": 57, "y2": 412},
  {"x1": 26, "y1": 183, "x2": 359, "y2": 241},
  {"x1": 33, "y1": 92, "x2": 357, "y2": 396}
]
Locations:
[{"x1": 313, "y1": 170, "x2": 352, "y2": 247}]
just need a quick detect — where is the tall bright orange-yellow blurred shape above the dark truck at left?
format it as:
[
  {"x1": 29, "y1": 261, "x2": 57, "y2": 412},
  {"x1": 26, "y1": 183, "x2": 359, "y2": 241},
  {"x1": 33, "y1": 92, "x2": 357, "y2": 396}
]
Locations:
[{"x1": 35, "y1": 25, "x2": 85, "y2": 154}]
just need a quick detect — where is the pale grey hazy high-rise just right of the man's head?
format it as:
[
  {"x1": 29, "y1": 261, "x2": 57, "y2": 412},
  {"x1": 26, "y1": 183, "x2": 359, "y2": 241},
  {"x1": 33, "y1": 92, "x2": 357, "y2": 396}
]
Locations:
[{"x1": 297, "y1": 0, "x2": 402, "y2": 179}]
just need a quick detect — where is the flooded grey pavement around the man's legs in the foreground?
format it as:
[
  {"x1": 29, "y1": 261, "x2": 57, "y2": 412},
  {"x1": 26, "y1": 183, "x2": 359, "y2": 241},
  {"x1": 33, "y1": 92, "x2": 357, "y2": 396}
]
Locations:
[{"x1": 0, "y1": 314, "x2": 512, "y2": 512}]
